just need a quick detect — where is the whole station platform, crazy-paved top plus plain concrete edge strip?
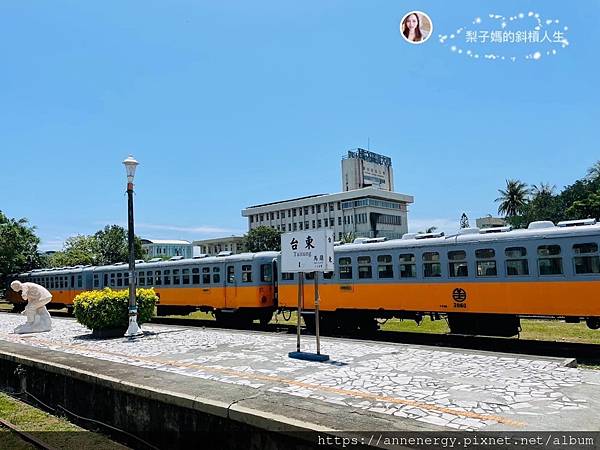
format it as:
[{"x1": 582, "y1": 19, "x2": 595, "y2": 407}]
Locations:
[{"x1": 0, "y1": 314, "x2": 600, "y2": 440}]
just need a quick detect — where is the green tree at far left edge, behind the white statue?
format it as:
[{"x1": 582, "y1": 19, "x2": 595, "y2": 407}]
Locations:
[{"x1": 0, "y1": 211, "x2": 41, "y2": 286}]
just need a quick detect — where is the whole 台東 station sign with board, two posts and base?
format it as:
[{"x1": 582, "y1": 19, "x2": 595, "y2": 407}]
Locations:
[{"x1": 281, "y1": 230, "x2": 334, "y2": 361}]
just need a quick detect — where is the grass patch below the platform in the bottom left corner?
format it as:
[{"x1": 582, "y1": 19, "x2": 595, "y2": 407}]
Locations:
[{"x1": 0, "y1": 393, "x2": 127, "y2": 450}]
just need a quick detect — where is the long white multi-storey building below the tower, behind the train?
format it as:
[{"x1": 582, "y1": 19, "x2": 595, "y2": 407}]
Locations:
[{"x1": 242, "y1": 187, "x2": 414, "y2": 243}]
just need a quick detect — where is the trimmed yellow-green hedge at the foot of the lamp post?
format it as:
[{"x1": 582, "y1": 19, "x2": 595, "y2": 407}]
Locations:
[{"x1": 73, "y1": 288, "x2": 158, "y2": 330}]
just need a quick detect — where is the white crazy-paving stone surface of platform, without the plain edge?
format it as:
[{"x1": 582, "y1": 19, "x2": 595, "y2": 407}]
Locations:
[{"x1": 0, "y1": 314, "x2": 600, "y2": 430}]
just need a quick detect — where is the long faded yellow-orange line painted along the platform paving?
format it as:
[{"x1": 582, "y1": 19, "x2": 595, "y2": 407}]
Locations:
[{"x1": 0, "y1": 333, "x2": 526, "y2": 427}]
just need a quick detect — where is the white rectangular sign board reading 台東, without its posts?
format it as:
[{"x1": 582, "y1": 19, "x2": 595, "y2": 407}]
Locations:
[{"x1": 281, "y1": 230, "x2": 334, "y2": 272}]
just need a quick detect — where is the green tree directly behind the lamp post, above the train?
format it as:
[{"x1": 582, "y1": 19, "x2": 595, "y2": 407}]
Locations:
[{"x1": 93, "y1": 225, "x2": 147, "y2": 265}]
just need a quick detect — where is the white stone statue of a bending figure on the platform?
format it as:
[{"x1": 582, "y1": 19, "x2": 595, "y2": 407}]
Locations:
[{"x1": 10, "y1": 280, "x2": 52, "y2": 334}]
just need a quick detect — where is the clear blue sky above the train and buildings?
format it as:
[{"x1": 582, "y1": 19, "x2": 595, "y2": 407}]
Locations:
[{"x1": 0, "y1": 0, "x2": 600, "y2": 250}]
